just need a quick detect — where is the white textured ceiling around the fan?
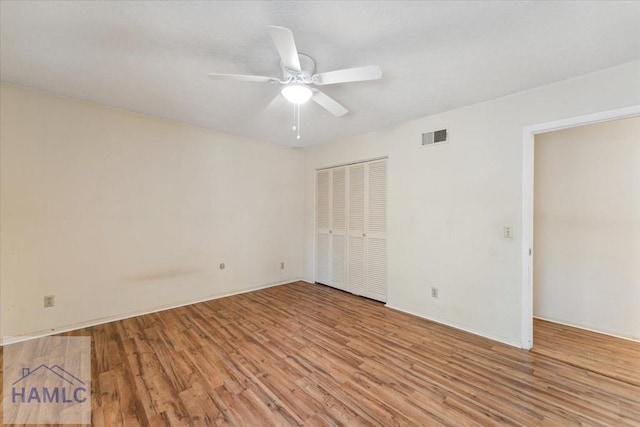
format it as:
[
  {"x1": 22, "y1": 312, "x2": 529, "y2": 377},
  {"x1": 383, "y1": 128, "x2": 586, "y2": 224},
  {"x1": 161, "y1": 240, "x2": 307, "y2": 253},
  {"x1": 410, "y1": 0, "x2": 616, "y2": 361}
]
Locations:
[{"x1": 0, "y1": 1, "x2": 640, "y2": 146}]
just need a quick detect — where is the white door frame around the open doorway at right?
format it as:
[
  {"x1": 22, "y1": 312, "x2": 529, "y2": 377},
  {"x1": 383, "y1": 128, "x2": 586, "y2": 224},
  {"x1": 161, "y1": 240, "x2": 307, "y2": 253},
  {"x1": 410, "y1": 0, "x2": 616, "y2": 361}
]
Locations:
[{"x1": 520, "y1": 105, "x2": 640, "y2": 350}]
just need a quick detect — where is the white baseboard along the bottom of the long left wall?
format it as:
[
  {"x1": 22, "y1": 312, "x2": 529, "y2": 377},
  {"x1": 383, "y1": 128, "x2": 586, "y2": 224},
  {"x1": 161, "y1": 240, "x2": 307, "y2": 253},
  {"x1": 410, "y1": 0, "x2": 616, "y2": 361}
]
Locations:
[{"x1": 0, "y1": 279, "x2": 302, "y2": 347}]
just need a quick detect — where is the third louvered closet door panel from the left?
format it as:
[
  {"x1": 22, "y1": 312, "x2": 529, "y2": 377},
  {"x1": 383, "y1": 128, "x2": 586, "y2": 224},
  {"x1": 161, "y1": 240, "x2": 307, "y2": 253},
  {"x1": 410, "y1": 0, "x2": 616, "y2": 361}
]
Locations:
[{"x1": 347, "y1": 164, "x2": 366, "y2": 295}]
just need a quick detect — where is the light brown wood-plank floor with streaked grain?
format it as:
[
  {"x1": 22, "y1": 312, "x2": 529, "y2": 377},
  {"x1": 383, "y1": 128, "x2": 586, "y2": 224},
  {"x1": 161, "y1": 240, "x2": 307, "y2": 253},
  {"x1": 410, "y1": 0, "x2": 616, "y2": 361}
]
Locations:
[{"x1": 1, "y1": 282, "x2": 640, "y2": 426}]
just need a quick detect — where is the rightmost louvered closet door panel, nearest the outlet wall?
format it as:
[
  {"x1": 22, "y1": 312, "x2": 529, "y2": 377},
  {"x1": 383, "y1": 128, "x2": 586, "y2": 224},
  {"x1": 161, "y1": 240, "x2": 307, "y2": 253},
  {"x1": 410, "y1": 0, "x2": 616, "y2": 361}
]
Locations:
[{"x1": 363, "y1": 160, "x2": 387, "y2": 302}]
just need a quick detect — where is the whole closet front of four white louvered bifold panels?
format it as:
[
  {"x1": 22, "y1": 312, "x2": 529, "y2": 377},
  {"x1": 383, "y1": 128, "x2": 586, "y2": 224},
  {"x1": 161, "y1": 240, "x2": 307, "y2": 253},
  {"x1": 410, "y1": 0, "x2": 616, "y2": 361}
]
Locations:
[{"x1": 316, "y1": 159, "x2": 387, "y2": 302}]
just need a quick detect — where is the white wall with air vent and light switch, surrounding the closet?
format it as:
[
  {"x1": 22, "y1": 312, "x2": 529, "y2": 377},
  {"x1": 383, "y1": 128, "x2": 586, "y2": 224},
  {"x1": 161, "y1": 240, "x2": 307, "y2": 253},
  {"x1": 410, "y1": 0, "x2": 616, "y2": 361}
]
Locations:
[{"x1": 304, "y1": 62, "x2": 640, "y2": 346}]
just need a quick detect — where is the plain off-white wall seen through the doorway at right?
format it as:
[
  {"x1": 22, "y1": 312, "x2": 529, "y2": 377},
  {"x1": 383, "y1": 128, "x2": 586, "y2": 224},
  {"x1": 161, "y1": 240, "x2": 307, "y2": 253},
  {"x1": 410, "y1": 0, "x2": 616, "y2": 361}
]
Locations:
[{"x1": 533, "y1": 118, "x2": 640, "y2": 340}]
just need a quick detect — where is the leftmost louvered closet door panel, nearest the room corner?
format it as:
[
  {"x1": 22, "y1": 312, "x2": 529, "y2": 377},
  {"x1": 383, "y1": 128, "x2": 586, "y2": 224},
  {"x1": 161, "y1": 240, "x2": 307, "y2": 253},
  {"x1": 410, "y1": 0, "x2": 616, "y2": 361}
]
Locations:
[{"x1": 316, "y1": 170, "x2": 331, "y2": 285}]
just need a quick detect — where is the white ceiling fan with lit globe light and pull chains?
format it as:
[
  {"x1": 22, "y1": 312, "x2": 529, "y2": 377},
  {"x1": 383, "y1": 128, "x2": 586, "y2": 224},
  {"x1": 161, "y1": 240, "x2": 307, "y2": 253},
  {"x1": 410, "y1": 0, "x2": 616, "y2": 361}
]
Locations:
[{"x1": 209, "y1": 26, "x2": 382, "y2": 119}]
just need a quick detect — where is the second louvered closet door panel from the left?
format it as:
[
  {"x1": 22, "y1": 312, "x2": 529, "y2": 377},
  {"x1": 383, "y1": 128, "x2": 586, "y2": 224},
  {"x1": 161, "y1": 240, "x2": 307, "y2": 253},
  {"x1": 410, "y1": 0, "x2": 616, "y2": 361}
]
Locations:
[{"x1": 329, "y1": 167, "x2": 347, "y2": 290}]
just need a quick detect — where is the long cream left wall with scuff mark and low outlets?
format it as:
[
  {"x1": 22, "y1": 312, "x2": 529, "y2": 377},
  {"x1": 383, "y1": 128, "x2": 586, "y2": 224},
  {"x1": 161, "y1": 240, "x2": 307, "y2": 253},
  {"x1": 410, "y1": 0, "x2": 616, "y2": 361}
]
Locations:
[{"x1": 0, "y1": 86, "x2": 303, "y2": 342}]
